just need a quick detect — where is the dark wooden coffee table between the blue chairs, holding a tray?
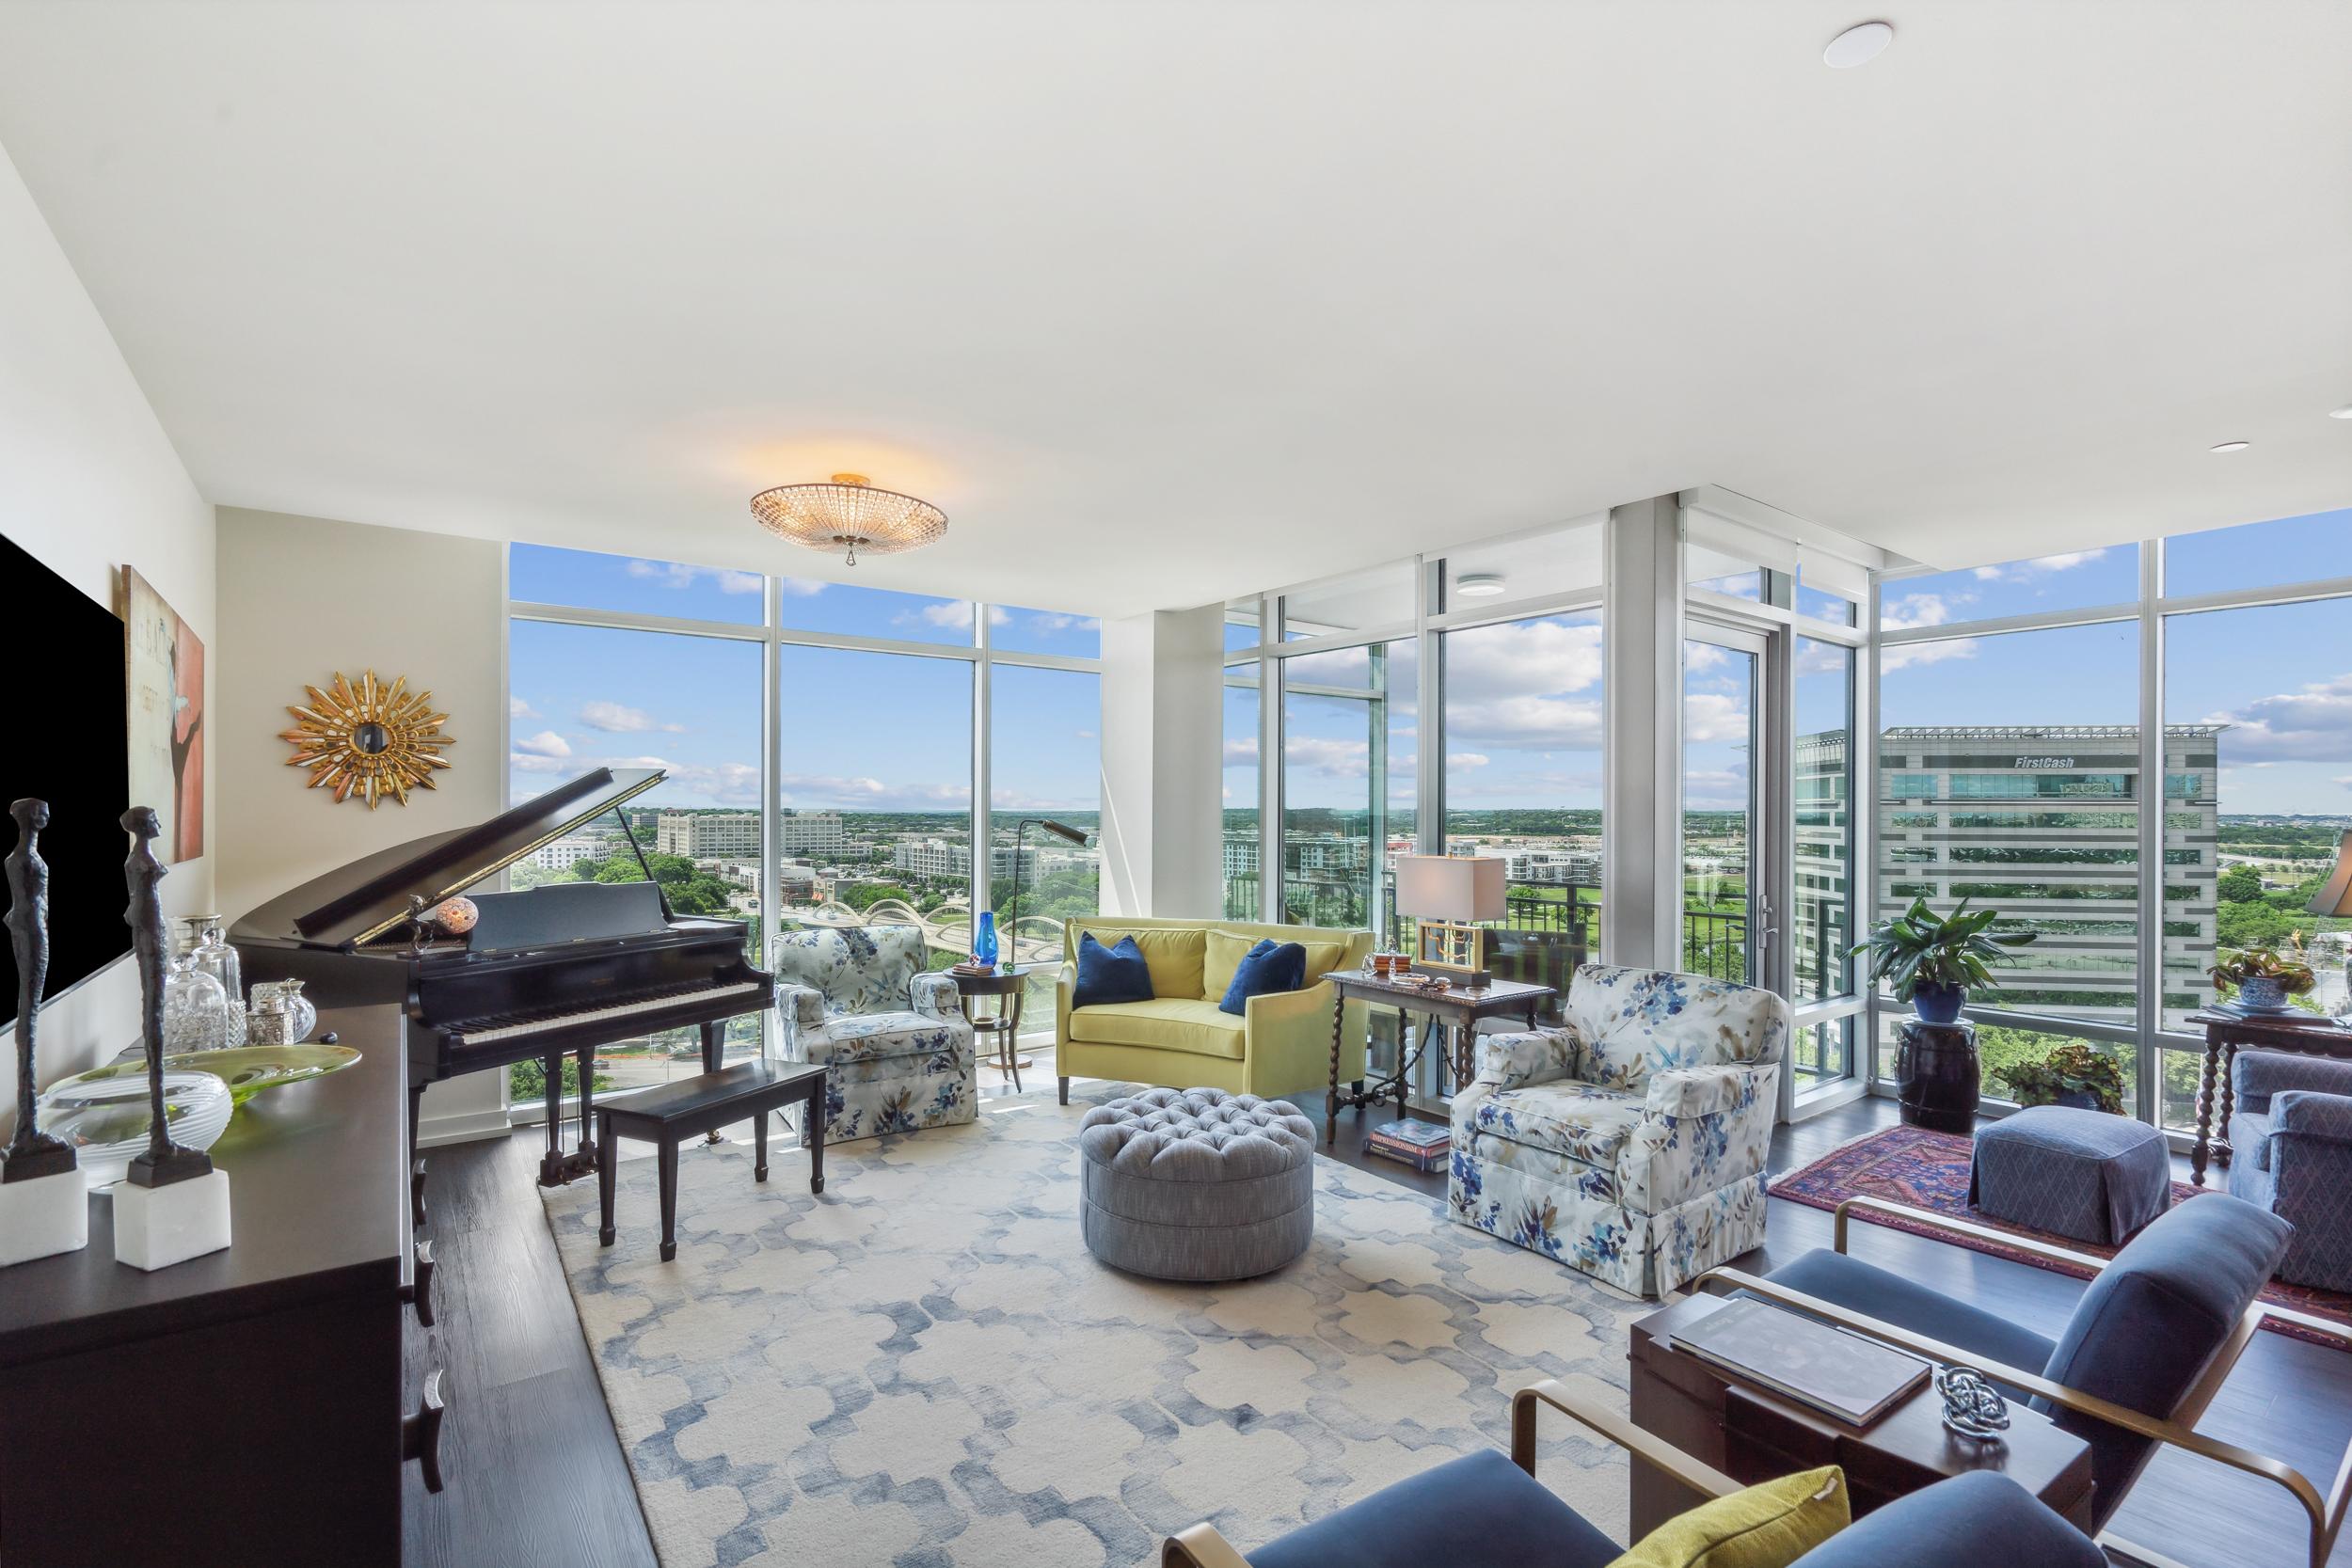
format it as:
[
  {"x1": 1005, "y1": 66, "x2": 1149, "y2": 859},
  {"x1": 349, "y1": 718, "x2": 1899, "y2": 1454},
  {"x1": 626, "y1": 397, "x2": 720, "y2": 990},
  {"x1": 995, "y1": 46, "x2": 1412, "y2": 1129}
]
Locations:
[{"x1": 1630, "y1": 1295, "x2": 2091, "y2": 1542}]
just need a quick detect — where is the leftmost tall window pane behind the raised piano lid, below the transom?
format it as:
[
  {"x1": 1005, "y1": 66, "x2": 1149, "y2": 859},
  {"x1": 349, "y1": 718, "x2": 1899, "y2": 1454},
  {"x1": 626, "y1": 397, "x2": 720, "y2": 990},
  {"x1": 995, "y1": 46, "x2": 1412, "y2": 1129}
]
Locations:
[{"x1": 508, "y1": 621, "x2": 762, "y2": 1105}]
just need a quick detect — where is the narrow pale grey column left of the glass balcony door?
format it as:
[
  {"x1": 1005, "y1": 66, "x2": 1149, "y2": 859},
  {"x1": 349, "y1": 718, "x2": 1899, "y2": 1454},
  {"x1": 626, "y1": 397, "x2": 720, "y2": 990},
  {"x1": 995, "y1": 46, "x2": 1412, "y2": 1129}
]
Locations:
[{"x1": 1602, "y1": 496, "x2": 1682, "y2": 969}]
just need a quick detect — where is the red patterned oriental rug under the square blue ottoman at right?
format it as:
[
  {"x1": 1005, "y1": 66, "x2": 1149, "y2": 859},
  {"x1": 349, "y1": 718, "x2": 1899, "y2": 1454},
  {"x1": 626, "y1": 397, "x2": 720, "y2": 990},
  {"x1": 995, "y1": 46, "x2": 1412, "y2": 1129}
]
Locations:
[{"x1": 1772, "y1": 1126, "x2": 2352, "y2": 1345}]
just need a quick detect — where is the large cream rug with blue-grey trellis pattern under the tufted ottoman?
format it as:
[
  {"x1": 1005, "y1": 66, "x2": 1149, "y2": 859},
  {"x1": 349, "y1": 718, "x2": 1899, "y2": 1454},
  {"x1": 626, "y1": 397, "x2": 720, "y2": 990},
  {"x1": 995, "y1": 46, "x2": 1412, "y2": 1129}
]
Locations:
[{"x1": 546, "y1": 1091, "x2": 1651, "y2": 1568}]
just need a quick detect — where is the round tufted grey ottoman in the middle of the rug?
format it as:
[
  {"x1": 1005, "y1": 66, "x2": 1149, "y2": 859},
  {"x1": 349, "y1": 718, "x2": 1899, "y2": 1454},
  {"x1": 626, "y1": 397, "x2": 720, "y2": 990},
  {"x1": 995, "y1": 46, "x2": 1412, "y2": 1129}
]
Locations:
[{"x1": 1077, "y1": 1088, "x2": 1315, "y2": 1279}]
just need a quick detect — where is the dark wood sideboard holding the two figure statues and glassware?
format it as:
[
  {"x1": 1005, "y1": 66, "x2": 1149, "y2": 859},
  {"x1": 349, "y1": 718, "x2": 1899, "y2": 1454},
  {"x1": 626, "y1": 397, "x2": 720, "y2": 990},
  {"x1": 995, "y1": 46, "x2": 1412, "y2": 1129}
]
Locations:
[{"x1": 0, "y1": 1006, "x2": 437, "y2": 1568}]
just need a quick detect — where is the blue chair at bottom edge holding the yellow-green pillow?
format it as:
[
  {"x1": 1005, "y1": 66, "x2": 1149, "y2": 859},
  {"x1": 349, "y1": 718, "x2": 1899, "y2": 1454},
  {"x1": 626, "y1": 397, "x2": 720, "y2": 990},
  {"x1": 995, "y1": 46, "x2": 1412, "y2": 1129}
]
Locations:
[{"x1": 1160, "y1": 1383, "x2": 2106, "y2": 1568}]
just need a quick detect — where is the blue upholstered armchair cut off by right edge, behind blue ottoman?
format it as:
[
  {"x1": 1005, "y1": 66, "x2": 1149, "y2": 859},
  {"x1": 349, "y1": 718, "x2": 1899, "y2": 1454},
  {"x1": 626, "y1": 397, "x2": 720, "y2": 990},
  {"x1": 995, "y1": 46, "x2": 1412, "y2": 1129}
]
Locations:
[{"x1": 2230, "y1": 1051, "x2": 2352, "y2": 1291}]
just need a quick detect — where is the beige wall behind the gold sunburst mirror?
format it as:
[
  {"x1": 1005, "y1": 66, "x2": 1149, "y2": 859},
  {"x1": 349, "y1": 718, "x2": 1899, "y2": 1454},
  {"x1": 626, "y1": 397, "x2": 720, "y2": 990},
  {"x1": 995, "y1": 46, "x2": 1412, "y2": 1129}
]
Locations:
[{"x1": 212, "y1": 505, "x2": 506, "y2": 1143}]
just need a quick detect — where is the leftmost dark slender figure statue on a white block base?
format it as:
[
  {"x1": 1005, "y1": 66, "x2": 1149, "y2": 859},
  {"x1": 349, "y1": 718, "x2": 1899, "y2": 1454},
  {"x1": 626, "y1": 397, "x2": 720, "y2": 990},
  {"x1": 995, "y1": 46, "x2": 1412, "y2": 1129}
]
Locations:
[{"x1": 0, "y1": 800, "x2": 89, "y2": 1267}]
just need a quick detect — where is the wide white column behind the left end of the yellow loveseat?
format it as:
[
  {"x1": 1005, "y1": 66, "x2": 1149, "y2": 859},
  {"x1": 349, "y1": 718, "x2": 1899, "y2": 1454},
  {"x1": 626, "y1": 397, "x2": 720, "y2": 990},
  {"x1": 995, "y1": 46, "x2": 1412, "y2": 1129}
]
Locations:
[{"x1": 1104, "y1": 604, "x2": 1226, "y2": 917}]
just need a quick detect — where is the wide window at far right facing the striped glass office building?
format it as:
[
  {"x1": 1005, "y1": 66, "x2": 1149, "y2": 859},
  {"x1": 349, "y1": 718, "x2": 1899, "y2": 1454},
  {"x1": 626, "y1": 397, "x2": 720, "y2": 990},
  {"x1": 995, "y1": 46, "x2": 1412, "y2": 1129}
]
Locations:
[{"x1": 1875, "y1": 513, "x2": 2352, "y2": 1131}]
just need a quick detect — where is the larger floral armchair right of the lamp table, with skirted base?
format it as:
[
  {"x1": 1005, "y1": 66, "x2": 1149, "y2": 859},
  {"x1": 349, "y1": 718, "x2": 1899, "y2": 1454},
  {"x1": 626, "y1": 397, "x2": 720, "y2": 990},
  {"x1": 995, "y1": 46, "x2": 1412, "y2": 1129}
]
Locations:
[{"x1": 1447, "y1": 964, "x2": 1790, "y2": 1295}]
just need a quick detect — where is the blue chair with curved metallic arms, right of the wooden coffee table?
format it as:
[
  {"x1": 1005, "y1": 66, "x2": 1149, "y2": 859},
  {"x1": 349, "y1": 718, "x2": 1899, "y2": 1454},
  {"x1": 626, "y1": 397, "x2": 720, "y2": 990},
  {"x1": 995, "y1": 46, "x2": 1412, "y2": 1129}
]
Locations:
[{"x1": 1698, "y1": 1192, "x2": 2352, "y2": 1568}]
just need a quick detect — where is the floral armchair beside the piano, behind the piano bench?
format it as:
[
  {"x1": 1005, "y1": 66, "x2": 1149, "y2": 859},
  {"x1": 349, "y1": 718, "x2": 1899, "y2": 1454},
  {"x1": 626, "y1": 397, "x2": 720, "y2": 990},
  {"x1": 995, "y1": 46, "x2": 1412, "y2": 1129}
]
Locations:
[{"x1": 776, "y1": 927, "x2": 978, "y2": 1143}]
